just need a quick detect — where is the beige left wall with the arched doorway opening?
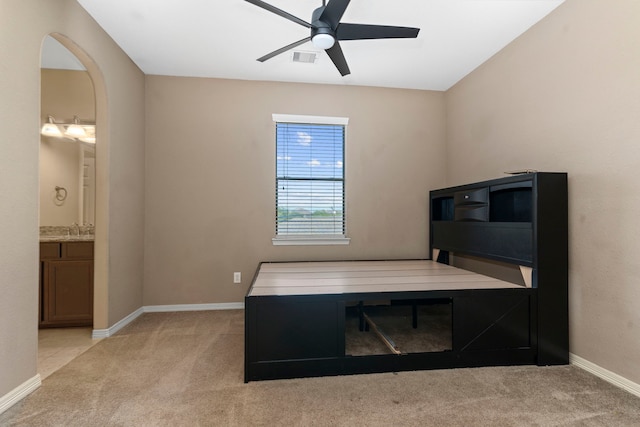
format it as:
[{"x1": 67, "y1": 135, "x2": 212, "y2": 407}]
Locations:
[{"x1": 0, "y1": 0, "x2": 144, "y2": 397}]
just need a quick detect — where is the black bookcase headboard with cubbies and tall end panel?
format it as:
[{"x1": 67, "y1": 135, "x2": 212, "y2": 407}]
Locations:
[{"x1": 429, "y1": 172, "x2": 569, "y2": 364}]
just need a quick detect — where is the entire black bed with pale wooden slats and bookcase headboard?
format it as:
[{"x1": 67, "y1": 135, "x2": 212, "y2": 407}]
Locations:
[{"x1": 245, "y1": 173, "x2": 569, "y2": 382}]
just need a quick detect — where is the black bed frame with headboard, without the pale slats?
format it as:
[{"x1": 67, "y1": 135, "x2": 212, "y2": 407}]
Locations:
[{"x1": 245, "y1": 172, "x2": 569, "y2": 382}]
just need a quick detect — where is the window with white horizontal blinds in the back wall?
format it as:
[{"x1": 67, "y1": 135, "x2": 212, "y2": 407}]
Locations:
[{"x1": 273, "y1": 115, "x2": 349, "y2": 244}]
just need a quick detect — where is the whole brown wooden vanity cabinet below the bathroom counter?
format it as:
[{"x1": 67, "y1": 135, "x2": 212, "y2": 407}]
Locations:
[{"x1": 39, "y1": 242, "x2": 93, "y2": 328}]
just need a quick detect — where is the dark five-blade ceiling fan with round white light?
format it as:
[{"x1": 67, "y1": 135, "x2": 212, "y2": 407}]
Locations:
[{"x1": 246, "y1": 0, "x2": 420, "y2": 76}]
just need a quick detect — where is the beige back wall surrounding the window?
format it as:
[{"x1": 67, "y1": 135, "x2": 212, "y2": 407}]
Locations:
[{"x1": 144, "y1": 76, "x2": 445, "y2": 305}]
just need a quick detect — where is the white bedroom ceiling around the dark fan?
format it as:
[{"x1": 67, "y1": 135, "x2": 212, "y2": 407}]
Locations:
[{"x1": 72, "y1": 0, "x2": 564, "y2": 90}]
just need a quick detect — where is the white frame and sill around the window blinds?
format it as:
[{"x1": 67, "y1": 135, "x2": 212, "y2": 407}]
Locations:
[{"x1": 271, "y1": 114, "x2": 351, "y2": 246}]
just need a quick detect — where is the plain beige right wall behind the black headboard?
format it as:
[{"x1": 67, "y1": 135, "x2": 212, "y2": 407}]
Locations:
[{"x1": 446, "y1": 0, "x2": 640, "y2": 383}]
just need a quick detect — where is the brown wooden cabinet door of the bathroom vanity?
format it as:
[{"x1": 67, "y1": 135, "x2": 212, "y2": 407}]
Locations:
[{"x1": 46, "y1": 261, "x2": 93, "y2": 326}]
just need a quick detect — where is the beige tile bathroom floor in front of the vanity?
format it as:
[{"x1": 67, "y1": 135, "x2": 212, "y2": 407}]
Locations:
[{"x1": 38, "y1": 328, "x2": 100, "y2": 380}]
